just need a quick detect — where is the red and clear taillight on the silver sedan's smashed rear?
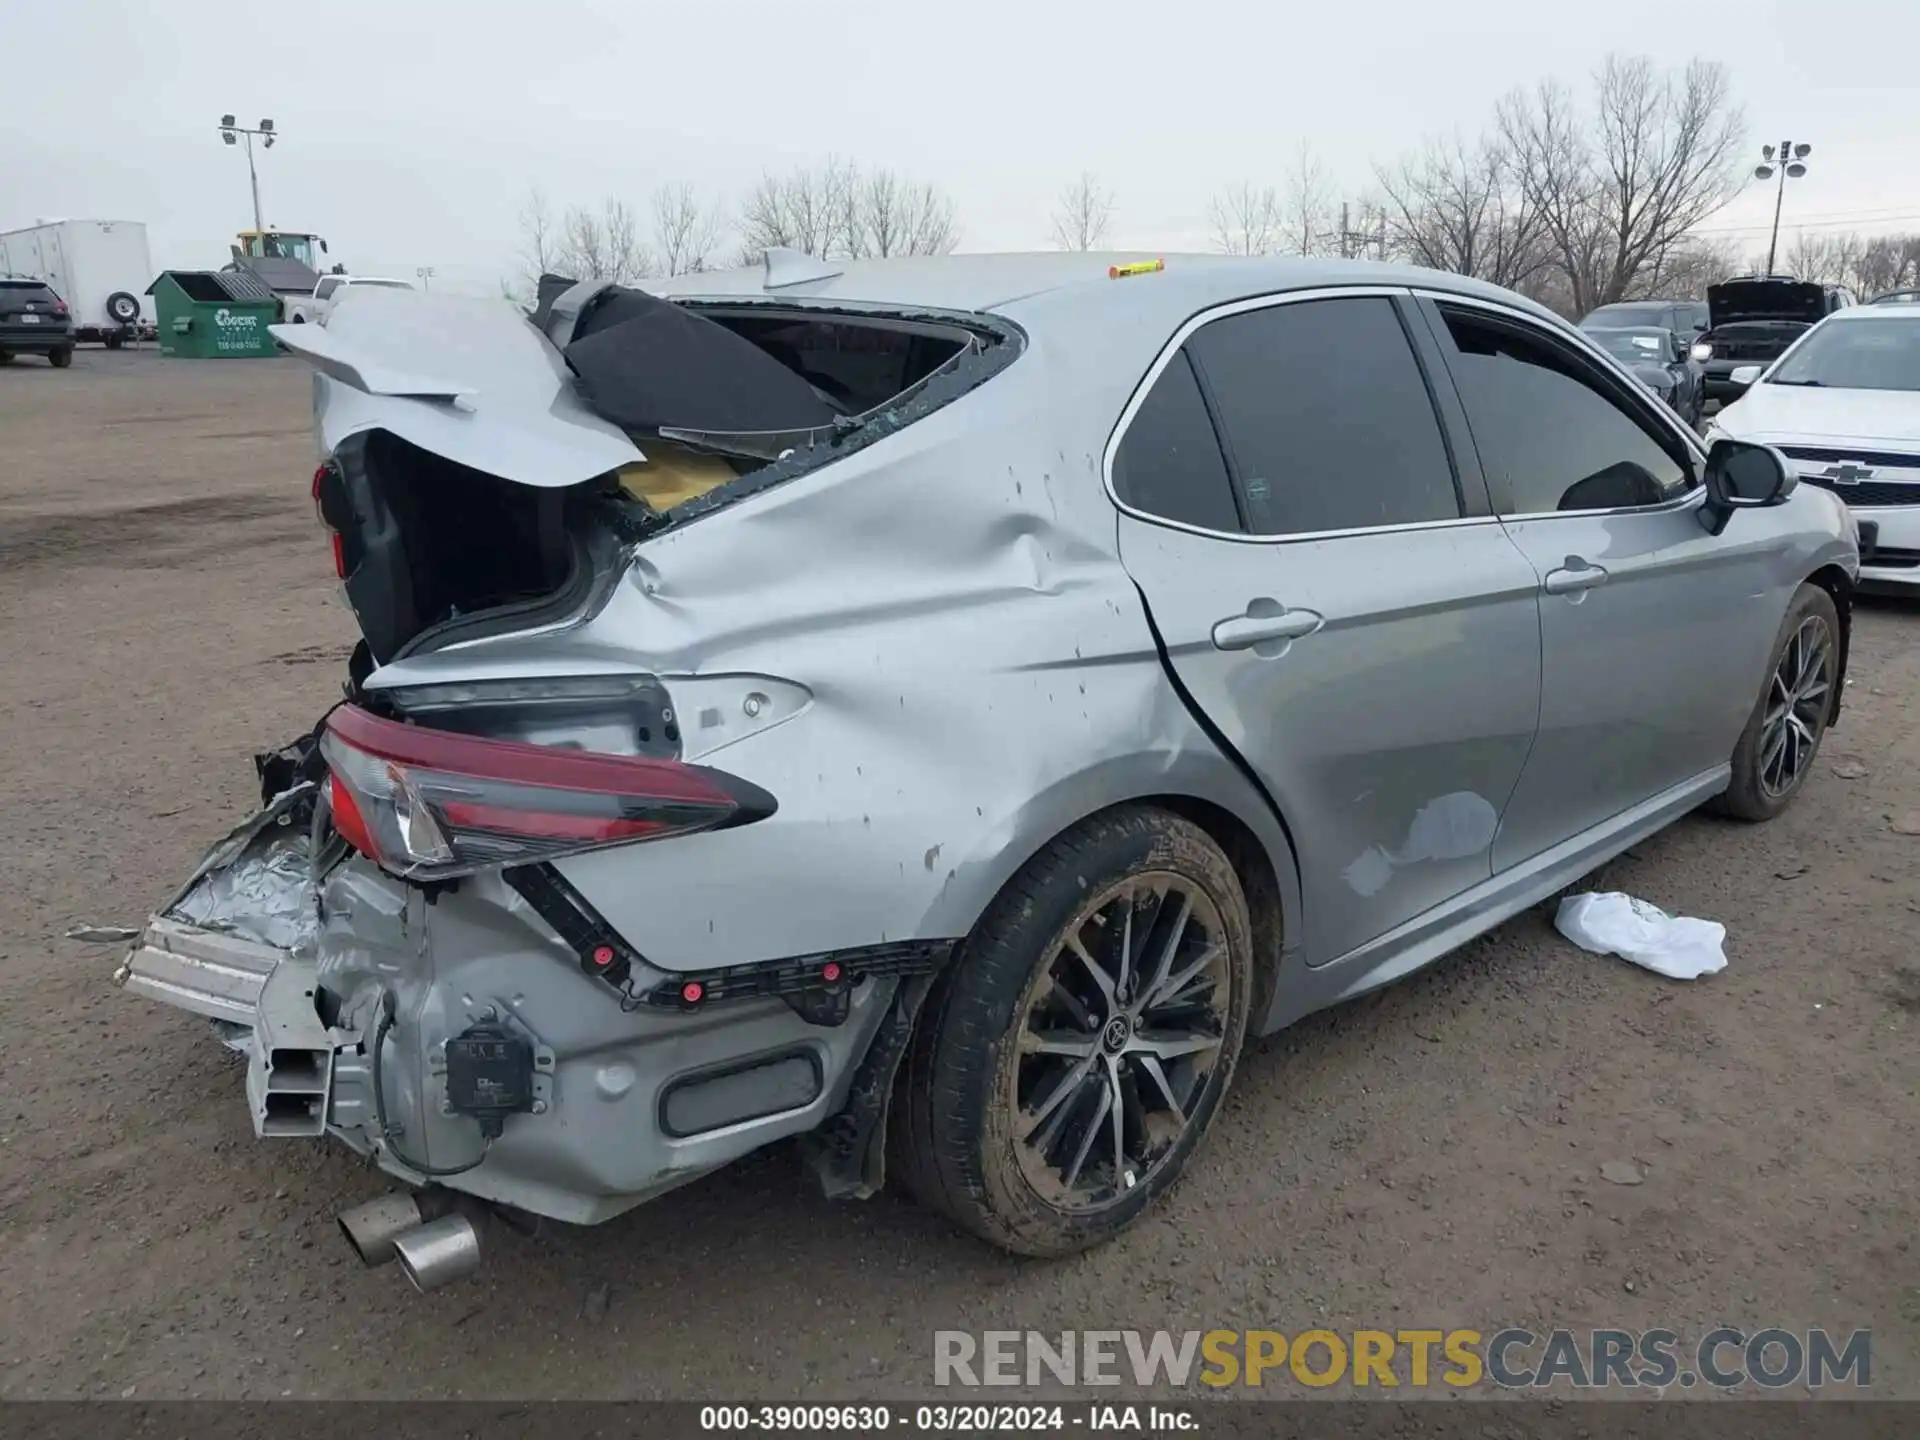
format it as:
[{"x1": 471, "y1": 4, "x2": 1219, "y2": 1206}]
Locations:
[{"x1": 321, "y1": 705, "x2": 774, "y2": 879}]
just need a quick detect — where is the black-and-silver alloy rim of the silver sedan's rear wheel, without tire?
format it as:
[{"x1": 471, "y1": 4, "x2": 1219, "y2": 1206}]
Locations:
[{"x1": 1010, "y1": 872, "x2": 1233, "y2": 1212}]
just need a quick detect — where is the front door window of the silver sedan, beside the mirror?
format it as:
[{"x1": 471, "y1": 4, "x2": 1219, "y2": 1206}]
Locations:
[{"x1": 1442, "y1": 309, "x2": 1692, "y2": 515}]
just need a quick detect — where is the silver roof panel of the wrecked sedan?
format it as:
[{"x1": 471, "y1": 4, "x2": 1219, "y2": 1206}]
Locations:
[{"x1": 641, "y1": 252, "x2": 1559, "y2": 332}]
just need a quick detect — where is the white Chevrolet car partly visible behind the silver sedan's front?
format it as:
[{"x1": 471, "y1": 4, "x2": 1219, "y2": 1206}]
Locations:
[{"x1": 1707, "y1": 305, "x2": 1920, "y2": 589}]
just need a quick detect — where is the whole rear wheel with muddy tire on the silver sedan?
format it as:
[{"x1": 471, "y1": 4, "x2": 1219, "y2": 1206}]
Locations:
[{"x1": 891, "y1": 806, "x2": 1254, "y2": 1256}]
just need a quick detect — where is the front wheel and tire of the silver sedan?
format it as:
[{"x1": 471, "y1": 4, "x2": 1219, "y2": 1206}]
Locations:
[{"x1": 1713, "y1": 586, "x2": 1839, "y2": 820}]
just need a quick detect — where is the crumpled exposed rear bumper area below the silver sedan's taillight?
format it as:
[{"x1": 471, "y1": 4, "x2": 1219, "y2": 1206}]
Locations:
[{"x1": 117, "y1": 826, "x2": 950, "y2": 1223}]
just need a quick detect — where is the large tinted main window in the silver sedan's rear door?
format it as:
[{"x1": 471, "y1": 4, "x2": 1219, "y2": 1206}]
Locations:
[{"x1": 1188, "y1": 296, "x2": 1459, "y2": 536}]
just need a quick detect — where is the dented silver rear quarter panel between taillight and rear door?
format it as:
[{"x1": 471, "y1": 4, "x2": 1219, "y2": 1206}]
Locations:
[{"x1": 371, "y1": 289, "x2": 1294, "y2": 970}]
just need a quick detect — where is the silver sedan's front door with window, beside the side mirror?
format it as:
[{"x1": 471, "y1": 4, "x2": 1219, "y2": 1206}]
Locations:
[{"x1": 1423, "y1": 298, "x2": 1786, "y2": 870}]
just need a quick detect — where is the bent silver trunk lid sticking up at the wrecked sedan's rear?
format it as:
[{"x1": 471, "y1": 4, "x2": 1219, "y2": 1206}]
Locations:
[{"x1": 271, "y1": 286, "x2": 645, "y2": 488}]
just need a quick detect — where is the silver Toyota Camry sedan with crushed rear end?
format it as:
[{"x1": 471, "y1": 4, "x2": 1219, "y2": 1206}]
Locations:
[{"x1": 119, "y1": 250, "x2": 1859, "y2": 1286}]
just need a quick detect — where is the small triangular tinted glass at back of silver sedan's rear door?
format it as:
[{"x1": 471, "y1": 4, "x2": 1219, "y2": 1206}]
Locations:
[{"x1": 1114, "y1": 351, "x2": 1240, "y2": 532}]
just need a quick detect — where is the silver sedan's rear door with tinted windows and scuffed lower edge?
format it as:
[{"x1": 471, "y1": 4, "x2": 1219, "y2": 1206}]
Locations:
[{"x1": 1108, "y1": 290, "x2": 1540, "y2": 964}]
